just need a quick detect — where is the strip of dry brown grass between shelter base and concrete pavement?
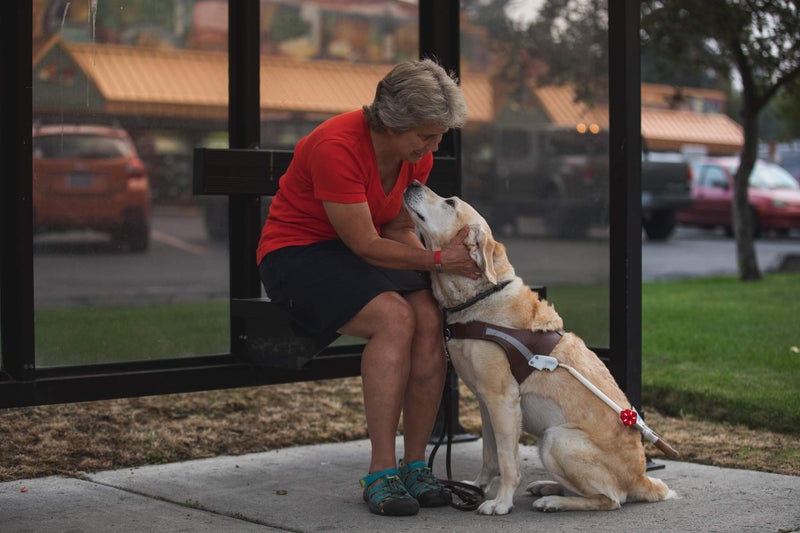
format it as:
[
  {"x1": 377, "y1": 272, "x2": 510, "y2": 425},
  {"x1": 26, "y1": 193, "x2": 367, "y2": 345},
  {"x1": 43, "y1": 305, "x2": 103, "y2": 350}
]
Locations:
[{"x1": 0, "y1": 378, "x2": 800, "y2": 481}]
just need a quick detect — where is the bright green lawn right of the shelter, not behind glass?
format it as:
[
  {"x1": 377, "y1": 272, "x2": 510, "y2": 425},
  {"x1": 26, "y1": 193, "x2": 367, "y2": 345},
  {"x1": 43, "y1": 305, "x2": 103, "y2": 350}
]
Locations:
[{"x1": 642, "y1": 274, "x2": 800, "y2": 433}]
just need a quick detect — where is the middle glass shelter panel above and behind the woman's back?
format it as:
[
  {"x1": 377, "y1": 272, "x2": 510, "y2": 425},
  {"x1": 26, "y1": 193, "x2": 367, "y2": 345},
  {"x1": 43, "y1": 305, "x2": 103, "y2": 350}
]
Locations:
[{"x1": 261, "y1": 0, "x2": 419, "y2": 344}]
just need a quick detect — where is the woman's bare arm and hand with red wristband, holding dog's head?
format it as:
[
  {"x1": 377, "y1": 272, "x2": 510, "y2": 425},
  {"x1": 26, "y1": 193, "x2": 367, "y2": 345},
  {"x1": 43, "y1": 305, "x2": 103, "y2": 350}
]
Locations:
[{"x1": 323, "y1": 202, "x2": 479, "y2": 278}]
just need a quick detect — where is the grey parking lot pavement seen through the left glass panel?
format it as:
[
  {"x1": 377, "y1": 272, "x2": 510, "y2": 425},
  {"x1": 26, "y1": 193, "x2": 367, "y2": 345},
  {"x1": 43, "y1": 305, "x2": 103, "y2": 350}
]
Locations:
[{"x1": 34, "y1": 208, "x2": 229, "y2": 307}]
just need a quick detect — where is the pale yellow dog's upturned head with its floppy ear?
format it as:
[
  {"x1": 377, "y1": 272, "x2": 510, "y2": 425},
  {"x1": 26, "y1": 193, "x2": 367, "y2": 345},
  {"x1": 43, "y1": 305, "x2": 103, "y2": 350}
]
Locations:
[{"x1": 403, "y1": 180, "x2": 502, "y2": 283}]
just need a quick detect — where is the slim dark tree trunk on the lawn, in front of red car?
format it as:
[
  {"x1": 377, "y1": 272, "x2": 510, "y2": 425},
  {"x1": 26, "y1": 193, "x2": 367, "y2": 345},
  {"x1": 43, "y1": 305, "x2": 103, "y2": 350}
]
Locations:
[{"x1": 732, "y1": 90, "x2": 761, "y2": 281}]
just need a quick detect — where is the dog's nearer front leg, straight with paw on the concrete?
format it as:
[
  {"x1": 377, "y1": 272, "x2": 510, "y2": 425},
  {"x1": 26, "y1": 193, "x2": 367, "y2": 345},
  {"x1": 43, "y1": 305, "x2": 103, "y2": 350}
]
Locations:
[{"x1": 478, "y1": 393, "x2": 522, "y2": 515}]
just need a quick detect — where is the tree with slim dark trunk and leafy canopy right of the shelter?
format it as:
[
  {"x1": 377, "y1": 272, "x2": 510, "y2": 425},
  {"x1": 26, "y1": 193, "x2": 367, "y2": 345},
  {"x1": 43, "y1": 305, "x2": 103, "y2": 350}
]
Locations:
[{"x1": 642, "y1": 0, "x2": 800, "y2": 281}]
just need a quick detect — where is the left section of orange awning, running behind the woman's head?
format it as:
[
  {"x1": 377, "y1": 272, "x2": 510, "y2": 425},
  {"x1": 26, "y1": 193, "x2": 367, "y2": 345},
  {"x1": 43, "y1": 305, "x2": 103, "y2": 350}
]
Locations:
[{"x1": 53, "y1": 43, "x2": 492, "y2": 122}]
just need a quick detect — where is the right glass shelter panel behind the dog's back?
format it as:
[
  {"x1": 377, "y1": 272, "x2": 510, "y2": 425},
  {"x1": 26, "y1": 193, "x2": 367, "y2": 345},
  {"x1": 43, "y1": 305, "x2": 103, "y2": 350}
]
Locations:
[{"x1": 461, "y1": 0, "x2": 609, "y2": 347}]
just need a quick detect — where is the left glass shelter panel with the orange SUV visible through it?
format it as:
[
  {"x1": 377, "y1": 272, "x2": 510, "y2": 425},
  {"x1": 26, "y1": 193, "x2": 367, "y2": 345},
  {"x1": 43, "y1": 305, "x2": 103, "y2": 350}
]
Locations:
[{"x1": 32, "y1": 0, "x2": 230, "y2": 366}]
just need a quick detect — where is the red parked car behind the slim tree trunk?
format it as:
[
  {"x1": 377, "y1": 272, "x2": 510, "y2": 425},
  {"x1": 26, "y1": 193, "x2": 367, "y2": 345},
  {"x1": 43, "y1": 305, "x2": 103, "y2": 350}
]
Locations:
[{"x1": 678, "y1": 157, "x2": 800, "y2": 236}]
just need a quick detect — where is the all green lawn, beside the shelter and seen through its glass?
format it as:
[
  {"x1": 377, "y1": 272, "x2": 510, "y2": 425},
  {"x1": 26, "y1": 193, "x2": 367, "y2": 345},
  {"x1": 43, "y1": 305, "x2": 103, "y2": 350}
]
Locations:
[{"x1": 26, "y1": 274, "x2": 800, "y2": 433}]
